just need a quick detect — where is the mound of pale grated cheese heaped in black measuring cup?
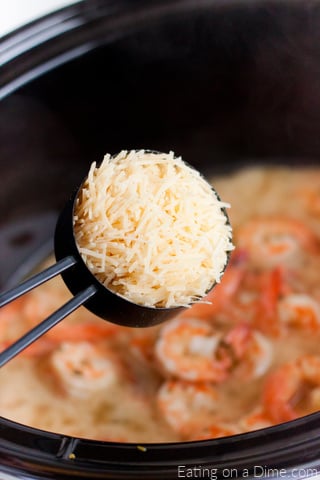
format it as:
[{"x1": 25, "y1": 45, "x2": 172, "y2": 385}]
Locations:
[{"x1": 74, "y1": 150, "x2": 233, "y2": 308}]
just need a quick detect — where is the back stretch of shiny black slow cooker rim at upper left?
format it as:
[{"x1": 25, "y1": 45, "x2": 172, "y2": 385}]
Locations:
[{"x1": 0, "y1": 0, "x2": 317, "y2": 100}]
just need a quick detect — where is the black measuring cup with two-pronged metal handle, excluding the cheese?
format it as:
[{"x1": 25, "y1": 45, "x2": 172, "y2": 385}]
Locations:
[{"x1": 0, "y1": 161, "x2": 229, "y2": 367}]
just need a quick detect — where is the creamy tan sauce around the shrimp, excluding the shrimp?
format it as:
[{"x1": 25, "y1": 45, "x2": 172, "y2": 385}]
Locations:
[{"x1": 0, "y1": 167, "x2": 320, "y2": 443}]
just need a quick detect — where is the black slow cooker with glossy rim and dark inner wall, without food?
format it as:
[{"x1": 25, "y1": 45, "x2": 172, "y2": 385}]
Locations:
[{"x1": 0, "y1": 0, "x2": 320, "y2": 480}]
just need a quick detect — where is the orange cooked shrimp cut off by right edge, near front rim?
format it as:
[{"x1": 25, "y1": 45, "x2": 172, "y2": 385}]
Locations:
[{"x1": 263, "y1": 355, "x2": 320, "y2": 423}]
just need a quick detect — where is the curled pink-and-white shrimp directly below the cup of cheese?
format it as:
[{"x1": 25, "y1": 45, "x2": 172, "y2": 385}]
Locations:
[{"x1": 155, "y1": 318, "x2": 230, "y2": 382}]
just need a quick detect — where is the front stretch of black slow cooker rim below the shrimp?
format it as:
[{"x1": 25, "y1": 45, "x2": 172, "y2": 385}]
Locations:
[{"x1": 0, "y1": 412, "x2": 320, "y2": 479}]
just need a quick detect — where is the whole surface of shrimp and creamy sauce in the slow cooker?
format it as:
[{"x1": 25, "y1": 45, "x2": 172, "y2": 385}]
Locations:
[{"x1": 0, "y1": 167, "x2": 320, "y2": 443}]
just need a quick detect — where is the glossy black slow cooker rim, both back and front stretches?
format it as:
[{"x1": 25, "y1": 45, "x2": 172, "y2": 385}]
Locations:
[{"x1": 0, "y1": 0, "x2": 320, "y2": 479}]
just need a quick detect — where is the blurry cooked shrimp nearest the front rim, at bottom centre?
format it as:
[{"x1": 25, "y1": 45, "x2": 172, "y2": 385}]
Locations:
[{"x1": 156, "y1": 380, "x2": 219, "y2": 439}]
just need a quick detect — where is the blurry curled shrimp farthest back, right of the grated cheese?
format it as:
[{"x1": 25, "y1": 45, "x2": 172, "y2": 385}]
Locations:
[{"x1": 234, "y1": 216, "x2": 319, "y2": 268}]
